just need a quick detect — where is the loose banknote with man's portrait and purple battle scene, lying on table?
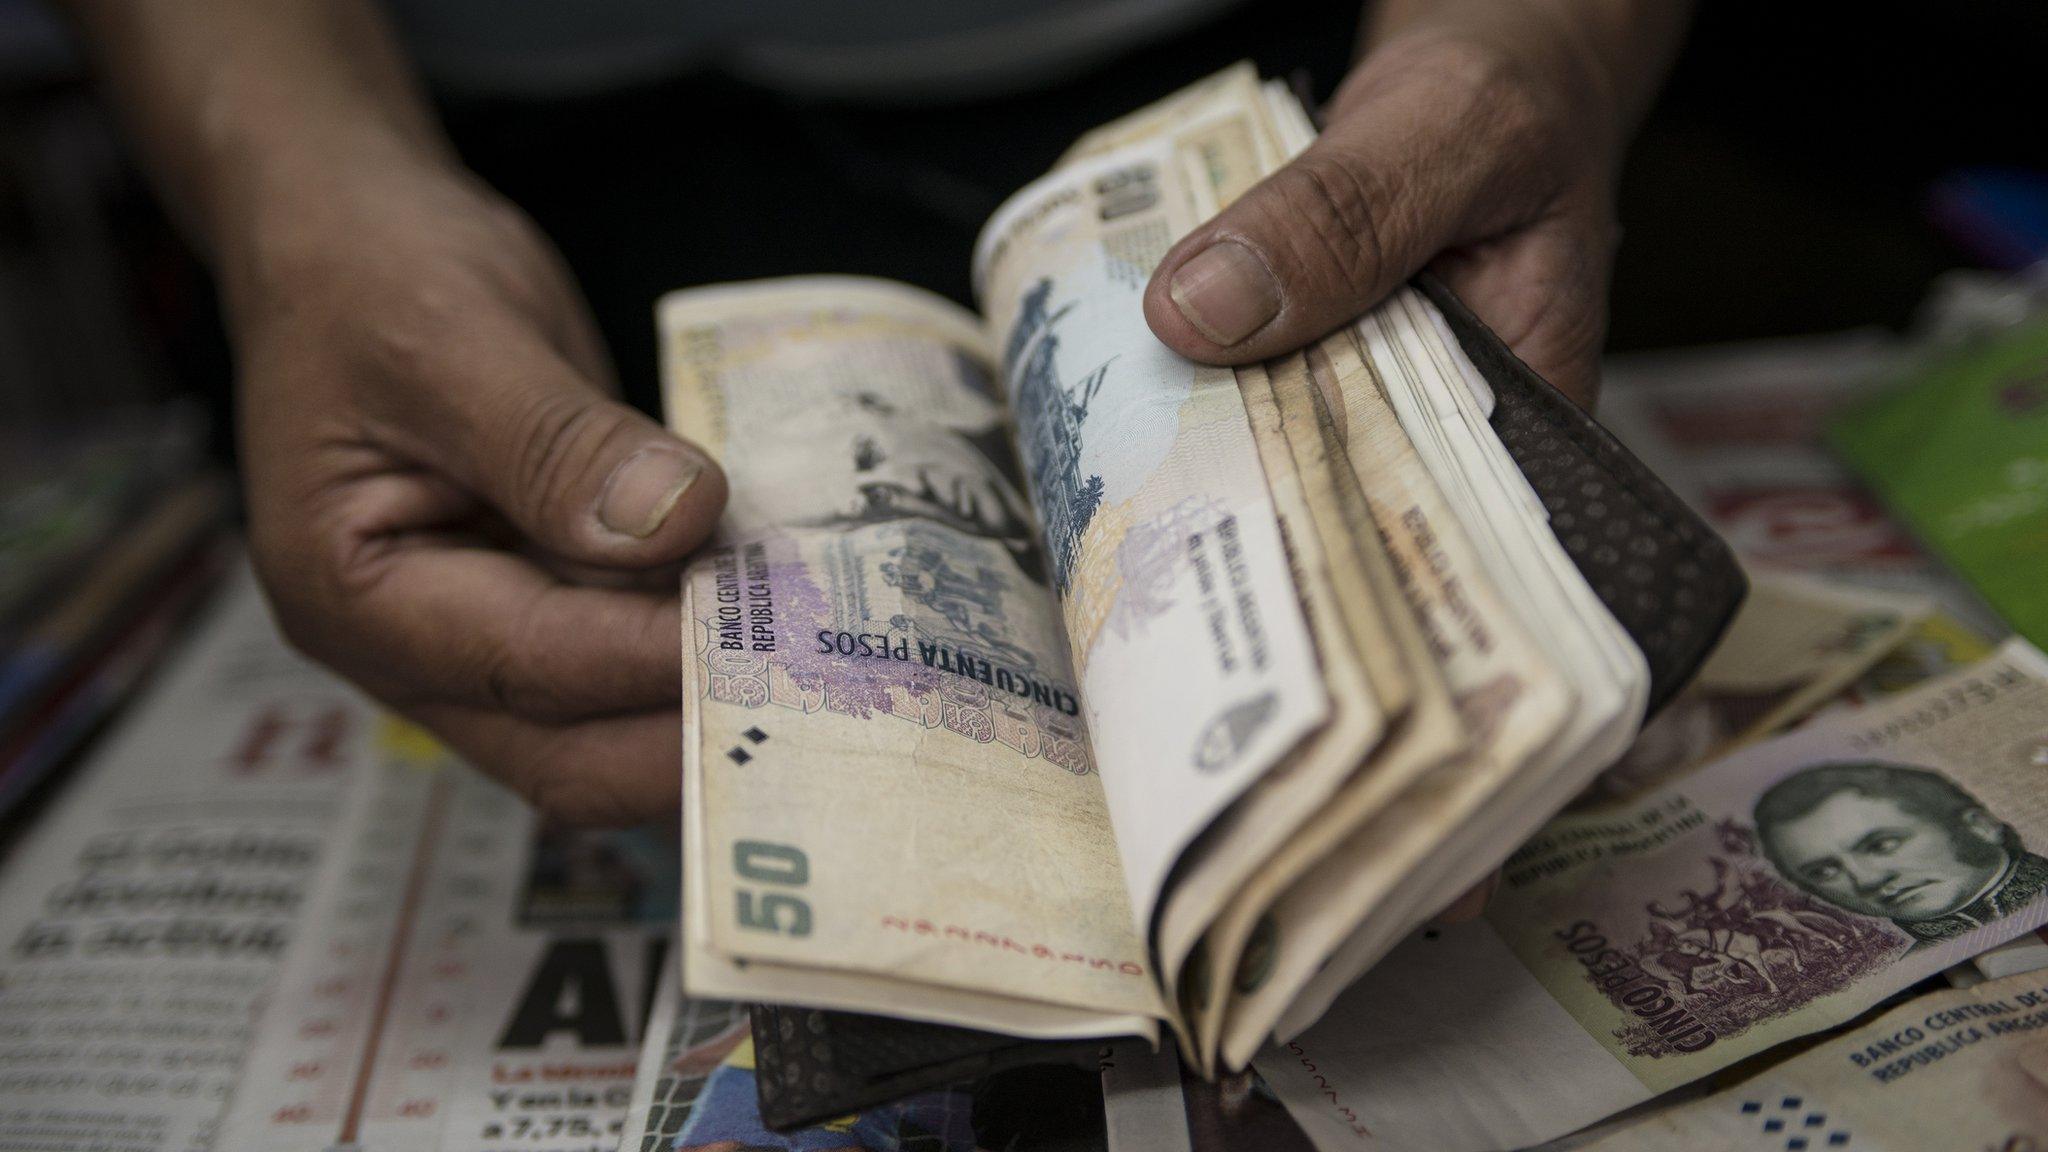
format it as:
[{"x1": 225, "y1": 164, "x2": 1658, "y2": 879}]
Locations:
[{"x1": 1257, "y1": 642, "x2": 2048, "y2": 1150}]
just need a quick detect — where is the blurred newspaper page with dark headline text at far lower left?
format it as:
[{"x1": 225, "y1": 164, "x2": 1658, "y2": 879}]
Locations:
[{"x1": 0, "y1": 568, "x2": 375, "y2": 1152}]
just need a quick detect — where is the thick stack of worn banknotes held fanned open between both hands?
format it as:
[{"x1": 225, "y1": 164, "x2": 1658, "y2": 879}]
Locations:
[{"x1": 659, "y1": 68, "x2": 1695, "y2": 1070}]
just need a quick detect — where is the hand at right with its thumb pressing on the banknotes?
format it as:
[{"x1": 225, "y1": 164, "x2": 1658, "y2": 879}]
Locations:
[{"x1": 1145, "y1": 0, "x2": 1683, "y2": 406}]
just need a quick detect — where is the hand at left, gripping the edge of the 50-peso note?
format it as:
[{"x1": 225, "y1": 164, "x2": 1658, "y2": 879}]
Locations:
[{"x1": 221, "y1": 150, "x2": 725, "y2": 822}]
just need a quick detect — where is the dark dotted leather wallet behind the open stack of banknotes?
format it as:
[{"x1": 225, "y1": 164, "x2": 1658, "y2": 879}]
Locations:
[{"x1": 754, "y1": 275, "x2": 1749, "y2": 1127}]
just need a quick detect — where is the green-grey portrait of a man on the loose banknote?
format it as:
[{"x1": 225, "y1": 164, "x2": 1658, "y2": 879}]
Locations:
[{"x1": 1755, "y1": 763, "x2": 2048, "y2": 947}]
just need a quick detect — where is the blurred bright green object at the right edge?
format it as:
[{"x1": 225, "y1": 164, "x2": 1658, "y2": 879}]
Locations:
[{"x1": 1829, "y1": 318, "x2": 2048, "y2": 646}]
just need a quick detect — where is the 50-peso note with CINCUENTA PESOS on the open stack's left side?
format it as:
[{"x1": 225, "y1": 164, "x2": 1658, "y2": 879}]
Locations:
[{"x1": 662, "y1": 279, "x2": 1163, "y2": 1020}]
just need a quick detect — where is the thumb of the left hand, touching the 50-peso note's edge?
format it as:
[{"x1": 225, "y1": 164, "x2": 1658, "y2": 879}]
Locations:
[{"x1": 430, "y1": 332, "x2": 725, "y2": 568}]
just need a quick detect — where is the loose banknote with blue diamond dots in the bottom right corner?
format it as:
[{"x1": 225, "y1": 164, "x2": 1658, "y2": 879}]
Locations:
[{"x1": 1585, "y1": 972, "x2": 2048, "y2": 1152}]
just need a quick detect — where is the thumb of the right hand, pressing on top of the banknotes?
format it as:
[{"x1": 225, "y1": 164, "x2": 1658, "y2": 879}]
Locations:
[{"x1": 1145, "y1": 50, "x2": 1528, "y2": 365}]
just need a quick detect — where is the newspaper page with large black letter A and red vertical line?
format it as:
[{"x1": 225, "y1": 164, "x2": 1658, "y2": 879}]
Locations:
[{"x1": 221, "y1": 736, "x2": 678, "y2": 1152}]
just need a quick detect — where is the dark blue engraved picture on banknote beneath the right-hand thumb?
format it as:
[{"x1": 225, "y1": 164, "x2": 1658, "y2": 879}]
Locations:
[{"x1": 1004, "y1": 277, "x2": 1112, "y2": 592}]
